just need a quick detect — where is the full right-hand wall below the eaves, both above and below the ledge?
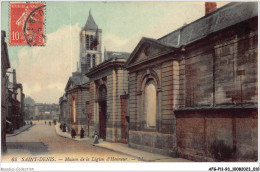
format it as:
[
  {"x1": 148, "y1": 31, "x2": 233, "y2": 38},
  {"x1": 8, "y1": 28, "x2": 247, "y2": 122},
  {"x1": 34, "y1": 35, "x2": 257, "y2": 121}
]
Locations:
[{"x1": 175, "y1": 18, "x2": 258, "y2": 161}]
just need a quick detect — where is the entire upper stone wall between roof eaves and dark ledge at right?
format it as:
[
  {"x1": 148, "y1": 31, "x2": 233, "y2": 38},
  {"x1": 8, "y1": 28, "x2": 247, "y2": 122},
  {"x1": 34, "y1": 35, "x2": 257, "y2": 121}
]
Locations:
[{"x1": 182, "y1": 17, "x2": 258, "y2": 107}]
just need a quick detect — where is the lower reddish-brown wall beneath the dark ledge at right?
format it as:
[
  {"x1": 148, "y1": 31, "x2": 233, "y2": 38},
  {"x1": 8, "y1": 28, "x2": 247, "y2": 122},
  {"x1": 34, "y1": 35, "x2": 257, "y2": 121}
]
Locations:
[{"x1": 176, "y1": 109, "x2": 258, "y2": 161}]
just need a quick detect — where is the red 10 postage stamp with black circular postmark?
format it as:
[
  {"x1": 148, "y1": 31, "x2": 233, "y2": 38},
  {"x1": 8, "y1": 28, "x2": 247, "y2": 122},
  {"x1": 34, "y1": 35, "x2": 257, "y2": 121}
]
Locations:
[{"x1": 9, "y1": 2, "x2": 46, "y2": 46}]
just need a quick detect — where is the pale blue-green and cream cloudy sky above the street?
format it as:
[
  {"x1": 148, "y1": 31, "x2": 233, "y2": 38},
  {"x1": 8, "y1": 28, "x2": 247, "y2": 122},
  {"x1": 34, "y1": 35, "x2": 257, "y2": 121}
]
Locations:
[{"x1": 1, "y1": 1, "x2": 228, "y2": 103}]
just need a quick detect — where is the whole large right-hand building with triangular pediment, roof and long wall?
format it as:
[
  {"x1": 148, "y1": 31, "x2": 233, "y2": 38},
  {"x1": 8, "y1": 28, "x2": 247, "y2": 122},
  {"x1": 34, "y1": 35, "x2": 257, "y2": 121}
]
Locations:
[{"x1": 126, "y1": 2, "x2": 258, "y2": 161}]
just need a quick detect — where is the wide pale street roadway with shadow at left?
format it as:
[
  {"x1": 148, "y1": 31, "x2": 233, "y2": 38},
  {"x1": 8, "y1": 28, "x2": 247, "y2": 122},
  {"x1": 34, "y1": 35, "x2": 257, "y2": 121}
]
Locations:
[{"x1": 2, "y1": 121, "x2": 138, "y2": 162}]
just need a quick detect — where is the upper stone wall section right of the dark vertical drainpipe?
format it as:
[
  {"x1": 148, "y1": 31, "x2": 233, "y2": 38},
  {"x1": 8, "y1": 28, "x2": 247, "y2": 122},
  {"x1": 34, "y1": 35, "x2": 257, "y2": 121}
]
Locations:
[{"x1": 214, "y1": 26, "x2": 258, "y2": 105}]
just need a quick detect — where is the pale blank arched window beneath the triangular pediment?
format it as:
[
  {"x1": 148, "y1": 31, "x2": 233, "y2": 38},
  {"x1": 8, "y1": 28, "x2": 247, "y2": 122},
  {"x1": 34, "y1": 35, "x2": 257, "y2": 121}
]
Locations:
[{"x1": 144, "y1": 80, "x2": 157, "y2": 128}]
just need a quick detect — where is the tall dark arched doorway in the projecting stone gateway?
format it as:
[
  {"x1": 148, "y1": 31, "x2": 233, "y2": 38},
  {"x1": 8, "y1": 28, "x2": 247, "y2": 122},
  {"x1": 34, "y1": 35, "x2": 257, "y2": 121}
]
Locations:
[{"x1": 98, "y1": 85, "x2": 107, "y2": 139}]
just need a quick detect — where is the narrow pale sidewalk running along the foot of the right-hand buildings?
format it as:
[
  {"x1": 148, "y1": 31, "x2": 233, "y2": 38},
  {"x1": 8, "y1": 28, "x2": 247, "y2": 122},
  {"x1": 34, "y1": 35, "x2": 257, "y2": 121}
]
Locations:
[{"x1": 55, "y1": 123, "x2": 191, "y2": 162}]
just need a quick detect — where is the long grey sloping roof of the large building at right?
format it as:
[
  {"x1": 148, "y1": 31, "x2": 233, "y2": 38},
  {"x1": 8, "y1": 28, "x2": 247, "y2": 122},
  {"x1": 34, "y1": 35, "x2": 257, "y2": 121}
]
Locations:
[{"x1": 158, "y1": 2, "x2": 258, "y2": 47}]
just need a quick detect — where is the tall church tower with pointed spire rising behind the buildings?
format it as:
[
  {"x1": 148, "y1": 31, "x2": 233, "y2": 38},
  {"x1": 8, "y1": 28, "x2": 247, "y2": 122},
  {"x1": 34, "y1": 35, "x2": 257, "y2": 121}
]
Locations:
[{"x1": 79, "y1": 10, "x2": 102, "y2": 74}]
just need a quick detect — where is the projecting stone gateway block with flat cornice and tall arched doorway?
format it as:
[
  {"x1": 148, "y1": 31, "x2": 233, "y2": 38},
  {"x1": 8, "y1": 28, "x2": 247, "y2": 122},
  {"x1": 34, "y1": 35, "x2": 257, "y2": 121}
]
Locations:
[{"x1": 86, "y1": 51, "x2": 129, "y2": 143}]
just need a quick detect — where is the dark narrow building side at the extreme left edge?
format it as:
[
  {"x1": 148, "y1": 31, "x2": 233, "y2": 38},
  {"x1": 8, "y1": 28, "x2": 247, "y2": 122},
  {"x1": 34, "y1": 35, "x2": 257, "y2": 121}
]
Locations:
[{"x1": 1, "y1": 31, "x2": 10, "y2": 153}]
